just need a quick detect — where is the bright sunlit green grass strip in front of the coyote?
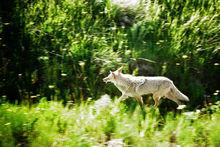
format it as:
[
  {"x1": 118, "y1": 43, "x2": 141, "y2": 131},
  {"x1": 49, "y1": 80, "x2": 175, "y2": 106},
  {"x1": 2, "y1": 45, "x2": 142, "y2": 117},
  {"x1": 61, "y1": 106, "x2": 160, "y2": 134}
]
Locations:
[{"x1": 0, "y1": 96, "x2": 220, "y2": 147}]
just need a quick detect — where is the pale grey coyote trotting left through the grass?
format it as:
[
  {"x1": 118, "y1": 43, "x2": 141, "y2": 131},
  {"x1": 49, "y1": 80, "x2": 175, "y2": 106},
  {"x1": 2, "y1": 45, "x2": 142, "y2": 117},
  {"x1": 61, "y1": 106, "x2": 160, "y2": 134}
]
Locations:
[{"x1": 103, "y1": 67, "x2": 189, "y2": 107}]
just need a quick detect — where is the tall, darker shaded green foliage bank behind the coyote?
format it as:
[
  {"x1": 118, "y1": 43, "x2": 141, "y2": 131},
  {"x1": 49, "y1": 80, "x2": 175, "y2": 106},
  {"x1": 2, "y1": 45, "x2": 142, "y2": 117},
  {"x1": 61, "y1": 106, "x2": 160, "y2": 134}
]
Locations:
[{"x1": 0, "y1": 0, "x2": 220, "y2": 108}]
